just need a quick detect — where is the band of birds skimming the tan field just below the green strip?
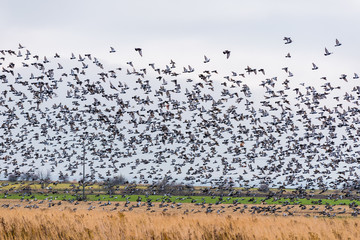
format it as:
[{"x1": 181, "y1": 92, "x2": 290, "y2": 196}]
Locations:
[{"x1": 1, "y1": 197, "x2": 360, "y2": 217}]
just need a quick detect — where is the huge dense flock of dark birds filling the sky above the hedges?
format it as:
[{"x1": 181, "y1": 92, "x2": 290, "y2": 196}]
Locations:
[{"x1": 0, "y1": 37, "x2": 360, "y2": 193}]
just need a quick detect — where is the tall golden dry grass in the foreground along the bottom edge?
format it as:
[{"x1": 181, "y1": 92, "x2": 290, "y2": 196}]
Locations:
[{"x1": 0, "y1": 209, "x2": 360, "y2": 240}]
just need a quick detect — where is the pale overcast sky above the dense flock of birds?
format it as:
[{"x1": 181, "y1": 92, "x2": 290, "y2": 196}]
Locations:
[{"x1": 0, "y1": 0, "x2": 360, "y2": 84}]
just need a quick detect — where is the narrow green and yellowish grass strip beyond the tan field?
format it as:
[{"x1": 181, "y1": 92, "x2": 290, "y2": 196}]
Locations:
[{"x1": 0, "y1": 181, "x2": 360, "y2": 205}]
